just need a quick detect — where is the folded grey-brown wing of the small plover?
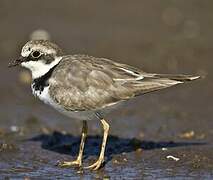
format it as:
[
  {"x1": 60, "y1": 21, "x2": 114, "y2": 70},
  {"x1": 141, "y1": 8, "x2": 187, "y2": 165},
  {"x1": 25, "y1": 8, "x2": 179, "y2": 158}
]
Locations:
[{"x1": 50, "y1": 55, "x2": 199, "y2": 111}]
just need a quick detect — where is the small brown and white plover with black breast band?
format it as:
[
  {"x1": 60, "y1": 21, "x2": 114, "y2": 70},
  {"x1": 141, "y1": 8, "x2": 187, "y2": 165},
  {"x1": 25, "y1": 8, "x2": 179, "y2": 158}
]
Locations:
[{"x1": 8, "y1": 40, "x2": 200, "y2": 170}]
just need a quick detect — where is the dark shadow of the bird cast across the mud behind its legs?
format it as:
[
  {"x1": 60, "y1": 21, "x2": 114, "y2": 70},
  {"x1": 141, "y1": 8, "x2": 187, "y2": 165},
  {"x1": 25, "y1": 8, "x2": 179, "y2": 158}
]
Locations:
[{"x1": 29, "y1": 131, "x2": 206, "y2": 161}]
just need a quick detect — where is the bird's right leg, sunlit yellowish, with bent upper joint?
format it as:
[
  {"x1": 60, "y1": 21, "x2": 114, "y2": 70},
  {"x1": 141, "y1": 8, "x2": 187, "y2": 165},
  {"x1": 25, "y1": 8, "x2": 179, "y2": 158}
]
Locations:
[{"x1": 85, "y1": 119, "x2": 109, "y2": 170}]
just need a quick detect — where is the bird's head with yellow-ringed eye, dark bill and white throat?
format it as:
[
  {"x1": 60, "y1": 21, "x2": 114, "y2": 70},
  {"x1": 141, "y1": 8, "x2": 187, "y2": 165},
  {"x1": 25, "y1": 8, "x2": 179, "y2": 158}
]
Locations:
[{"x1": 9, "y1": 40, "x2": 63, "y2": 79}]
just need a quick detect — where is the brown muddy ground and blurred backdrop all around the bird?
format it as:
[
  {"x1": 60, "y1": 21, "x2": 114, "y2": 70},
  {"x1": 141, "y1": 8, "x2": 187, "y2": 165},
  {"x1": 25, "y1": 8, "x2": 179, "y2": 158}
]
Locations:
[{"x1": 0, "y1": 0, "x2": 213, "y2": 179}]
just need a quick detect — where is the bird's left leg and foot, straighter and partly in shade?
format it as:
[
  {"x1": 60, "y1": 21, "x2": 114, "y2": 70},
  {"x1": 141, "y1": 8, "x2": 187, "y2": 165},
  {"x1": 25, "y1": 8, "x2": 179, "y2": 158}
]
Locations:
[{"x1": 59, "y1": 121, "x2": 88, "y2": 167}]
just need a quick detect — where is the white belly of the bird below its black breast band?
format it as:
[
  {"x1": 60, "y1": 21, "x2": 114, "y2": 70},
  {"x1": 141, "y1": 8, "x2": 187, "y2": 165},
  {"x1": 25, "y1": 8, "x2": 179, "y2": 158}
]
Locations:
[{"x1": 32, "y1": 86, "x2": 97, "y2": 120}]
